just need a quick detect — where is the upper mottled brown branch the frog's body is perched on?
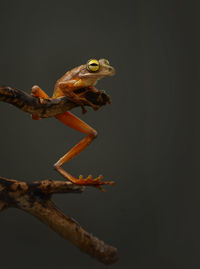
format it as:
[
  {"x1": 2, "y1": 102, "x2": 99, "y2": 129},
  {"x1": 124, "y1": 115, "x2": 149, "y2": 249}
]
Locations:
[{"x1": 0, "y1": 86, "x2": 110, "y2": 115}]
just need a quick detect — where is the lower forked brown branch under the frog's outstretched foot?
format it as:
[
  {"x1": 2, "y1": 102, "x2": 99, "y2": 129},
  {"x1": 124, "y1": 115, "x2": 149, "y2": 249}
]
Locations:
[{"x1": 0, "y1": 177, "x2": 118, "y2": 264}]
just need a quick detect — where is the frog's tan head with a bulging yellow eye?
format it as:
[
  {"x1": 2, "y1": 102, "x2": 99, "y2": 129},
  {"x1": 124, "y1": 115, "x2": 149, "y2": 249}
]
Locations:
[{"x1": 79, "y1": 59, "x2": 115, "y2": 86}]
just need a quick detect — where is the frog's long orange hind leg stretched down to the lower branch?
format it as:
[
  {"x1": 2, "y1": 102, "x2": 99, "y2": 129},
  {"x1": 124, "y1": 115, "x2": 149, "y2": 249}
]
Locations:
[{"x1": 54, "y1": 112, "x2": 114, "y2": 190}]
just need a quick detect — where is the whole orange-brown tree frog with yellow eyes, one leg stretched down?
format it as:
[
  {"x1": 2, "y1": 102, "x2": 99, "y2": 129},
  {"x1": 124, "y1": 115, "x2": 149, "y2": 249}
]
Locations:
[{"x1": 31, "y1": 59, "x2": 115, "y2": 190}]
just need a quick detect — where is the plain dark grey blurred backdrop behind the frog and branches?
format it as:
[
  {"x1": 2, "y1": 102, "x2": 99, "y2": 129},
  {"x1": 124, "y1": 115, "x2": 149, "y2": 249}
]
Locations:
[{"x1": 0, "y1": 0, "x2": 200, "y2": 269}]
